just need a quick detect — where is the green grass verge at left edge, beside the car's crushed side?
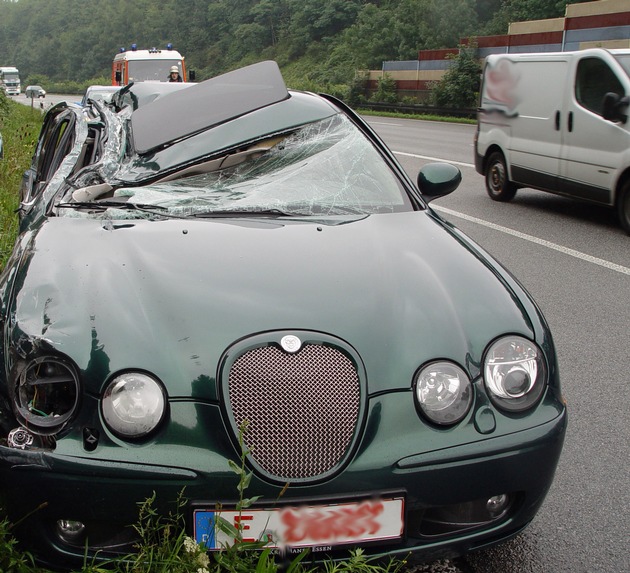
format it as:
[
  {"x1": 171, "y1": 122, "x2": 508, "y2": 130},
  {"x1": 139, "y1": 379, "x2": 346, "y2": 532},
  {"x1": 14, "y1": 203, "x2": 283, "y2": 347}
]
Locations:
[{"x1": 0, "y1": 90, "x2": 42, "y2": 270}]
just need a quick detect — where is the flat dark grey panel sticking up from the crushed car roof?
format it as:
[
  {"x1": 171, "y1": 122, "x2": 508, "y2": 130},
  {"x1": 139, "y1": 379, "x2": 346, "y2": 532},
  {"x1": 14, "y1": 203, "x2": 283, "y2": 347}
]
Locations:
[{"x1": 131, "y1": 61, "x2": 289, "y2": 154}]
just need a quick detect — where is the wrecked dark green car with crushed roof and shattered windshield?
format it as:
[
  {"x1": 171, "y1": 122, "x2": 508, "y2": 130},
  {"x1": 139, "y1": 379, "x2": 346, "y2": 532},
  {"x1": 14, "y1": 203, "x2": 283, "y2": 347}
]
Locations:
[{"x1": 0, "y1": 62, "x2": 567, "y2": 568}]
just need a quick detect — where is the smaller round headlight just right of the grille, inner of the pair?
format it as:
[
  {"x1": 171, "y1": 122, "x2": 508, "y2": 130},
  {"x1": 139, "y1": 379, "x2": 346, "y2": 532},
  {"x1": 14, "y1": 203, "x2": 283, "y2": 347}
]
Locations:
[{"x1": 414, "y1": 361, "x2": 473, "y2": 425}]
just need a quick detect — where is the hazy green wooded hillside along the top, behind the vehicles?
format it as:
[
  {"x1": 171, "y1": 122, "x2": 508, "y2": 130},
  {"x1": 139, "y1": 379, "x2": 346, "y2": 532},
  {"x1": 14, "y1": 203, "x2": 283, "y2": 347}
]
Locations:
[{"x1": 0, "y1": 0, "x2": 588, "y2": 96}]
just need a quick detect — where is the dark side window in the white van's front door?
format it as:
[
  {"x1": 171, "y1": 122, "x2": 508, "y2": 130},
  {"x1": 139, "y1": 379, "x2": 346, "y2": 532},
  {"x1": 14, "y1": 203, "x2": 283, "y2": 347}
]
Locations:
[{"x1": 575, "y1": 58, "x2": 625, "y2": 115}]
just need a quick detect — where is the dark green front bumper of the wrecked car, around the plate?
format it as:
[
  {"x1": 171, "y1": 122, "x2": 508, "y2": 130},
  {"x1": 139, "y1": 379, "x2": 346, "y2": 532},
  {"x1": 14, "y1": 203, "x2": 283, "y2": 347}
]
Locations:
[{"x1": 0, "y1": 395, "x2": 567, "y2": 567}]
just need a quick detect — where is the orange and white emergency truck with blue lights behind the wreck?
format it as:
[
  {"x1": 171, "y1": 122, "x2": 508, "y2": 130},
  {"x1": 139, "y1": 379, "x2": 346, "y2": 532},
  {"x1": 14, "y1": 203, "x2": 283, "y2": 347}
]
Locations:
[{"x1": 112, "y1": 44, "x2": 195, "y2": 86}]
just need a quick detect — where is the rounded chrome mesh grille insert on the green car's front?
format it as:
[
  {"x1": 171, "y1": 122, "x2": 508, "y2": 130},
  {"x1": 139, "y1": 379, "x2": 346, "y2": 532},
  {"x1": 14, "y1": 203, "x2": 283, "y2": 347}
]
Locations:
[{"x1": 228, "y1": 344, "x2": 360, "y2": 480}]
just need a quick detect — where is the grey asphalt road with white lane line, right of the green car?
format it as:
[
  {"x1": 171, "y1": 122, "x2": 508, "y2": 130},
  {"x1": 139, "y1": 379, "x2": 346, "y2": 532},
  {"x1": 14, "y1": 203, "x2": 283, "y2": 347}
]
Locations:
[{"x1": 366, "y1": 117, "x2": 630, "y2": 573}]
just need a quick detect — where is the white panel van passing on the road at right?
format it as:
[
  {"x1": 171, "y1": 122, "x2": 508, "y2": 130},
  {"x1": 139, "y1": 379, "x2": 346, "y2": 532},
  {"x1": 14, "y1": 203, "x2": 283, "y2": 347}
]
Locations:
[{"x1": 475, "y1": 48, "x2": 630, "y2": 234}]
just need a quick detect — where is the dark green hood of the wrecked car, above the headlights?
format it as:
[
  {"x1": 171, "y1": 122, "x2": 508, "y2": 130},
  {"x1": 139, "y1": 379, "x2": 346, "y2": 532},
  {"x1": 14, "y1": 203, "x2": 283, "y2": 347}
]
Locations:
[{"x1": 7, "y1": 211, "x2": 535, "y2": 400}]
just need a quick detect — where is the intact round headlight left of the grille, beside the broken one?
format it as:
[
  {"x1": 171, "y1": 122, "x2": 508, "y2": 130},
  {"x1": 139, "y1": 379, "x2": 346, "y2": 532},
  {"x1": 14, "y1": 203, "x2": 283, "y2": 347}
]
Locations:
[{"x1": 102, "y1": 372, "x2": 166, "y2": 438}]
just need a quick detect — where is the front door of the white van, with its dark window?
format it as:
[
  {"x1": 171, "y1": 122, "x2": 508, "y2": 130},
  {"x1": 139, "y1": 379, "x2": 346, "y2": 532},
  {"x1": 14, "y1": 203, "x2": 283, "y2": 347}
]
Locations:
[{"x1": 560, "y1": 55, "x2": 630, "y2": 205}]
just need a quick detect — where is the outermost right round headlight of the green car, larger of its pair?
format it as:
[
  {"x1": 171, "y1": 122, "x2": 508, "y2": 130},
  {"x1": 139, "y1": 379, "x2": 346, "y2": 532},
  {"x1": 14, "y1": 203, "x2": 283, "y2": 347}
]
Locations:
[{"x1": 484, "y1": 336, "x2": 547, "y2": 412}]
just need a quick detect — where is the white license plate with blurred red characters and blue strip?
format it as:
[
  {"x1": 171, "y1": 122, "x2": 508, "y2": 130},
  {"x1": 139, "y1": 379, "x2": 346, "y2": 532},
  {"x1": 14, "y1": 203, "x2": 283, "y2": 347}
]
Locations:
[{"x1": 193, "y1": 497, "x2": 404, "y2": 550}]
